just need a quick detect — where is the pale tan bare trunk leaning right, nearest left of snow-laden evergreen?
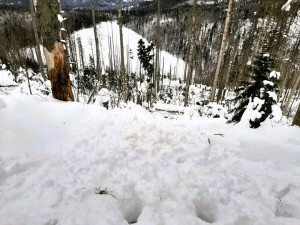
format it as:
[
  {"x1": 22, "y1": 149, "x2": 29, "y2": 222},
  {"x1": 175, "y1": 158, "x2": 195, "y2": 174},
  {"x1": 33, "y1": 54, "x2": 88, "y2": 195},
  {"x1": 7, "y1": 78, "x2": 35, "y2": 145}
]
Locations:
[{"x1": 210, "y1": 0, "x2": 232, "y2": 102}]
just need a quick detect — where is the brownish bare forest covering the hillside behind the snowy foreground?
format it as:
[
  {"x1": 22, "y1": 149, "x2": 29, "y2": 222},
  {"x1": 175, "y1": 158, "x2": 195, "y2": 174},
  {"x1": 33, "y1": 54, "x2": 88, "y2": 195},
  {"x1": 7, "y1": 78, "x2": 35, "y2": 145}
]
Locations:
[{"x1": 0, "y1": 0, "x2": 300, "y2": 125}]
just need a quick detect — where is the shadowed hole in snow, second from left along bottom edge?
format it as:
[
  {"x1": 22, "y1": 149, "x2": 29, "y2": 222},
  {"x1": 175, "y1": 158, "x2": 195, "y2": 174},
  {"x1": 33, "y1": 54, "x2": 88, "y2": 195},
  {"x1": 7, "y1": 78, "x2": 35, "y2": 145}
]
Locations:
[{"x1": 194, "y1": 200, "x2": 216, "y2": 223}]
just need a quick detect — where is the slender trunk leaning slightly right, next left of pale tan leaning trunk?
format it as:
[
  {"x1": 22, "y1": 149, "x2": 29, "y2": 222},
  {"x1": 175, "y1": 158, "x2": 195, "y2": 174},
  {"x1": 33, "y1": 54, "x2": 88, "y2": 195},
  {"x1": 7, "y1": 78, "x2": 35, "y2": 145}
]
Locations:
[{"x1": 184, "y1": 0, "x2": 197, "y2": 106}]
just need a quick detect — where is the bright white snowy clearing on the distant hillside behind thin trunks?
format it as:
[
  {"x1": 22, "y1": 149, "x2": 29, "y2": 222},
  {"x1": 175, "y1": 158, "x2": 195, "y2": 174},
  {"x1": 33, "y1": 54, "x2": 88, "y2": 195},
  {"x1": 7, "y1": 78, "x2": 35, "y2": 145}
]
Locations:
[{"x1": 75, "y1": 22, "x2": 185, "y2": 78}]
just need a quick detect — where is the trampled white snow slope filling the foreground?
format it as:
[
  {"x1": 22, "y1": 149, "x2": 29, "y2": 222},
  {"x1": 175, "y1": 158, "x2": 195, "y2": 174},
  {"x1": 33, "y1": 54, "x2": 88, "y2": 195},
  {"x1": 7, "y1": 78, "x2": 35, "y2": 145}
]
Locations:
[{"x1": 0, "y1": 95, "x2": 300, "y2": 225}]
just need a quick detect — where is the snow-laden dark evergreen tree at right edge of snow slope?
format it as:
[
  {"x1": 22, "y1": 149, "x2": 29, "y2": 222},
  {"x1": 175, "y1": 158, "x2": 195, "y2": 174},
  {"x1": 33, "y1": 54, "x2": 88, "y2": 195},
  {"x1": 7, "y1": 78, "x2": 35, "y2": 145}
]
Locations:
[{"x1": 228, "y1": 53, "x2": 279, "y2": 128}]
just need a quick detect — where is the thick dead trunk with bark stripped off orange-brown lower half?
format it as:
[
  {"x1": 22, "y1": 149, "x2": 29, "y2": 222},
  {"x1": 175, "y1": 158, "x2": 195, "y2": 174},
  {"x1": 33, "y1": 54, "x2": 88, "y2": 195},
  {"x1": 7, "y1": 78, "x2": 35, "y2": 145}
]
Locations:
[{"x1": 34, "y1": 0, "x2": 74, "y2": 101}]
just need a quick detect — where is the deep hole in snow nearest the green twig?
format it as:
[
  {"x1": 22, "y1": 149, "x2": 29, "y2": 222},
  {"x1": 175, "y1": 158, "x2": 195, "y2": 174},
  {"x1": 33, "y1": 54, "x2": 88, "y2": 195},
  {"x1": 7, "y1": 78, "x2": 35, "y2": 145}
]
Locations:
[{"x1": 118, "y1": 196, "x2": 143, "y2": 224}]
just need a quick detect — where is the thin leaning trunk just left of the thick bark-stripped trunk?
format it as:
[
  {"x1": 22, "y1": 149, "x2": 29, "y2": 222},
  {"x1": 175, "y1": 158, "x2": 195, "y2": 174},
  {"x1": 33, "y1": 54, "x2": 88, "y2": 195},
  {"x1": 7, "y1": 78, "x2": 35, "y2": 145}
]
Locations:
[{"x1": 29, "y1": 0, "x2": 47, "y2": 80}]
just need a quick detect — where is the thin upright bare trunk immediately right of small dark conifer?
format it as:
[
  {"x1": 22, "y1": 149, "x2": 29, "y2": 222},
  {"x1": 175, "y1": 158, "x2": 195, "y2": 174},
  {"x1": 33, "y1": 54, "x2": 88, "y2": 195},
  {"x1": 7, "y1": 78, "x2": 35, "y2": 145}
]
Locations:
[{"x1": 154, "y1": 0, "x2": 161, "y2": 98}]
